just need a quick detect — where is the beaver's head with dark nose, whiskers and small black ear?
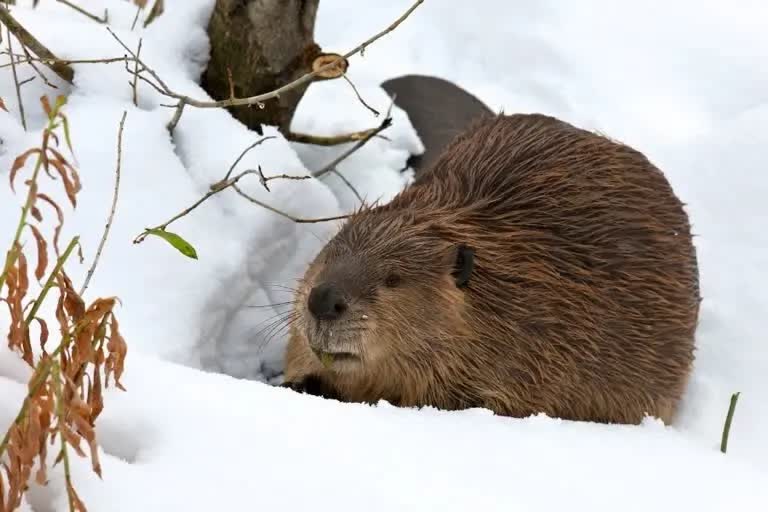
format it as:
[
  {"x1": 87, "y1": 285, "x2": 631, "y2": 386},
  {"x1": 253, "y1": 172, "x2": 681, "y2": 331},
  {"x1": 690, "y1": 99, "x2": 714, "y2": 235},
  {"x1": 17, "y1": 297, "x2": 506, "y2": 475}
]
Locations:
[{"x1": 296, "y1": 209, "x2": 474, "y2": 373}]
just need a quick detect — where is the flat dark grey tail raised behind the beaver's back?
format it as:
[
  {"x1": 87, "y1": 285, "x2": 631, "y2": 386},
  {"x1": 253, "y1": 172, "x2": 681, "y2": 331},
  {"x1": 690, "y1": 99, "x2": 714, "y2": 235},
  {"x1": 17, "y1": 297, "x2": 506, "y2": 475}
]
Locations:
[{"x1": 381, "y1": 74, "x2": 492, "y2": 175}]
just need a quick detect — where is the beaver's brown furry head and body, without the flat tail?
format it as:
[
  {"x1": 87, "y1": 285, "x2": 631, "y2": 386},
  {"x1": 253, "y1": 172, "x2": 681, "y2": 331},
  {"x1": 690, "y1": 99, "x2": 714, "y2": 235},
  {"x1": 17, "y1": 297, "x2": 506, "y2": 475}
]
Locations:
[{"x1": 283, "y1": 113, "x2": 701, "y2": 424}]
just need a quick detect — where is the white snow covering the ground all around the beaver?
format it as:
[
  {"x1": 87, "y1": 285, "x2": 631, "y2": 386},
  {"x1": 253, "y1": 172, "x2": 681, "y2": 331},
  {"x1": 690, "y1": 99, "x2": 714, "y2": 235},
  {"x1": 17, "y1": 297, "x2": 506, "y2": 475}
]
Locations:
[{"x1": 0, "y1": 0, "x2": 768, "y2": 512}]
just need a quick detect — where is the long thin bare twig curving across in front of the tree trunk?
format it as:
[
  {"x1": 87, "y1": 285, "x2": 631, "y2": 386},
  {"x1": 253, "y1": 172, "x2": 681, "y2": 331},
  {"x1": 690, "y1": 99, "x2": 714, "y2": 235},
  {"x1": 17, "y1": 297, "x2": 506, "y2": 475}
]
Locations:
[{"x1": 101, "y1": 0, "x2": 424, "y2": 131}]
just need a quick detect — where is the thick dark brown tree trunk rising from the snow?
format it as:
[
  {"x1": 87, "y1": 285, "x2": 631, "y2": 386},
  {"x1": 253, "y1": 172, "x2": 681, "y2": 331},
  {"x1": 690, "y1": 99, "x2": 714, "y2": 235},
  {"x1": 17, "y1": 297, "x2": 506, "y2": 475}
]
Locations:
[{"x1": 202, "y1": 0, "x2": 320, "y2": 132}]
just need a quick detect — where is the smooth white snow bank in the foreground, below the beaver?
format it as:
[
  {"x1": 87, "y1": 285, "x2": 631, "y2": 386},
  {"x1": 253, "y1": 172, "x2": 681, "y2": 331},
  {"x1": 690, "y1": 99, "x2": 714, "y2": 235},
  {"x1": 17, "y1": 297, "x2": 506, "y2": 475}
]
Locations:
[{"x1": 0, "y1": 356, "x2": 768, "y2": 512}]
